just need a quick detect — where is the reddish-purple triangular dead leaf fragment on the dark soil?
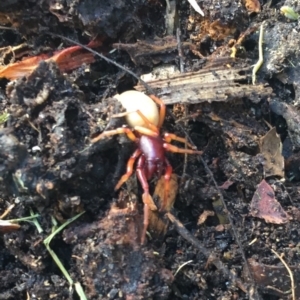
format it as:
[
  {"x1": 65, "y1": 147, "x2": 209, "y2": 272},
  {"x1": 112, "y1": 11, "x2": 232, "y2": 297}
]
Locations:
[{"x1": 250, "y1": 179, "x2": 289, "y2": 224}]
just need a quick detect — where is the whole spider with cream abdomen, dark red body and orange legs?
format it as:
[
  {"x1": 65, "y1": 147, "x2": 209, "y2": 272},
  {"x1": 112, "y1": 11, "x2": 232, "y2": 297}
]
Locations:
[{"x1": 92, "y1": 91, "x2": 202, "y2": 243}]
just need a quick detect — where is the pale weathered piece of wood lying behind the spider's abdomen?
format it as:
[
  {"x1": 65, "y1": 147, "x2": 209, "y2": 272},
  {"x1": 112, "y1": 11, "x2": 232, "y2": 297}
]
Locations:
[{"x1": 135, "y1": 67, "x2": 272, "y2": 104}]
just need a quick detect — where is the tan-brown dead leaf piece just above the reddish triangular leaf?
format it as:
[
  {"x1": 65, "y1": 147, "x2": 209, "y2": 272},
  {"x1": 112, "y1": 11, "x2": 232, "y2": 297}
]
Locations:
[{"x1": 260, "y1": 127, "x2": 284, "y2": 177}]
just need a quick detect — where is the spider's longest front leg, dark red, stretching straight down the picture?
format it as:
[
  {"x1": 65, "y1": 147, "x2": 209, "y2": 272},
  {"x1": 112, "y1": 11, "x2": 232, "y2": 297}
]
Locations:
[{"x1": 136, "y1": 156, "x2": 157, "y2": 244}]
